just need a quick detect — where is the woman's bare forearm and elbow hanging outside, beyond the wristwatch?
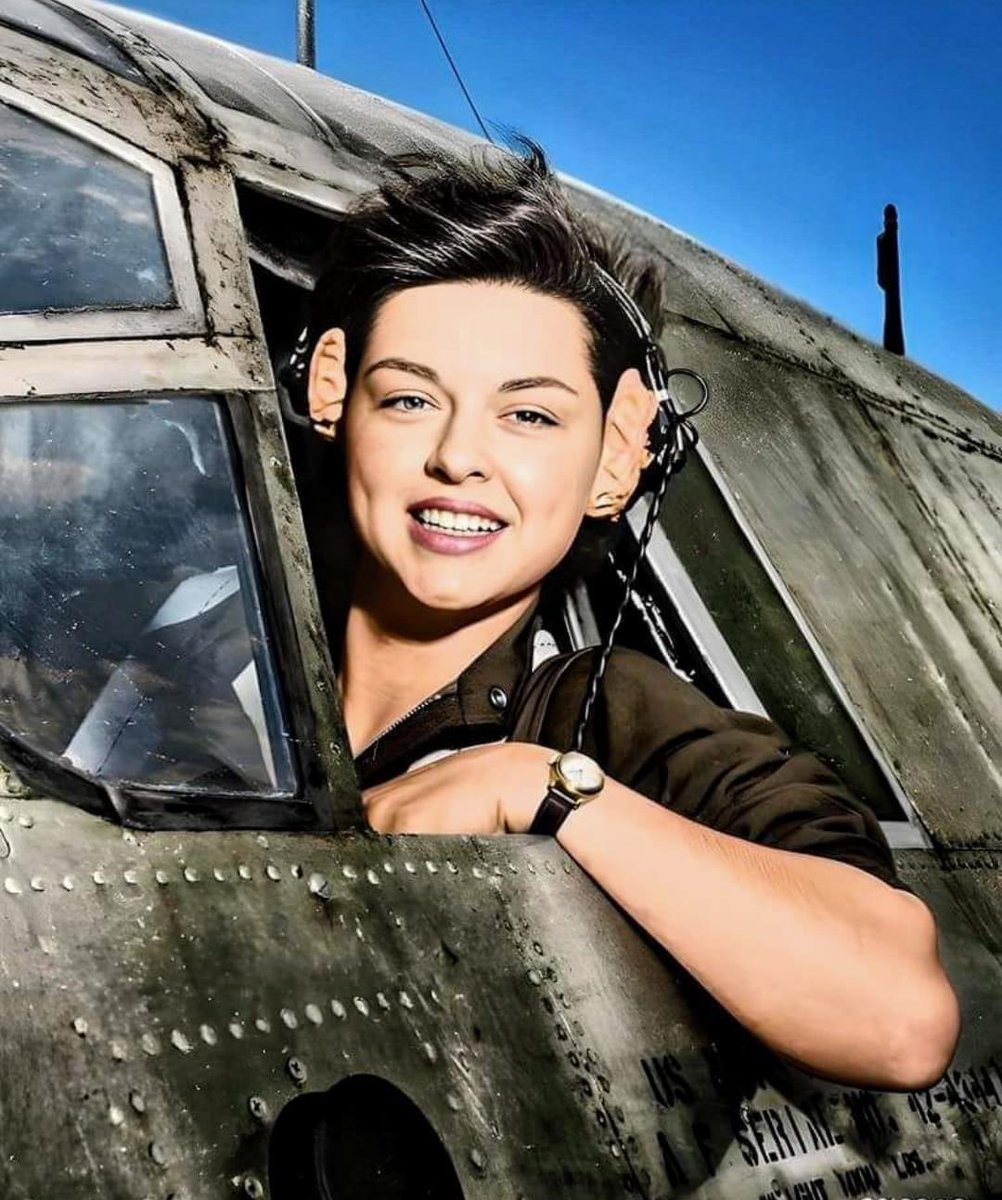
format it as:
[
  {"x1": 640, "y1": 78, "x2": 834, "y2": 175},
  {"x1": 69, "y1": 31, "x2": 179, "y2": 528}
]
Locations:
[{"x1": 557, "y1": 779, "x2": 960, "y2": 1090}]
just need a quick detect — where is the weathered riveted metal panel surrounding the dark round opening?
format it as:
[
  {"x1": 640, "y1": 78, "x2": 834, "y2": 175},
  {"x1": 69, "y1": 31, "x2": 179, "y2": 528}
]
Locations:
[{"x1": 0, "y1": 802, "x2": 622, "y2": 1200}]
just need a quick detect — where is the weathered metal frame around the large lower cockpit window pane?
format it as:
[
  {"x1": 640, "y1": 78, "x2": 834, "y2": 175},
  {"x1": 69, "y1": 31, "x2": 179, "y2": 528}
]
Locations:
[{"x1": 0, "y1": 150, "x2": 357, "y2": 832}]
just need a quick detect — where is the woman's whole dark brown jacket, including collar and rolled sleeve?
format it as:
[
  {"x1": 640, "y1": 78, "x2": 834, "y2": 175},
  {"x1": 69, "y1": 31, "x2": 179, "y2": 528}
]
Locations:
[{"x1": 355, "y1": 595, "x2": 912, "y2": 892}]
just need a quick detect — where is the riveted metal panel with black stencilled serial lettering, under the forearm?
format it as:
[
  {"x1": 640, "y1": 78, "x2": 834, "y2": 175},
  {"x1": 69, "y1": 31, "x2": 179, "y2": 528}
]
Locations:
[{"x1": 475, "y1": 840, "x2": 1002, "y2": 1200}]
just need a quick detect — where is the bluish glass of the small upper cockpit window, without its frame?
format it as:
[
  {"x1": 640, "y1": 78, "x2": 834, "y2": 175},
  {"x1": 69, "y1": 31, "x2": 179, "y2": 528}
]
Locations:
[{"x1": 0, "y1": 102, "x2": 176, "y2": 313}]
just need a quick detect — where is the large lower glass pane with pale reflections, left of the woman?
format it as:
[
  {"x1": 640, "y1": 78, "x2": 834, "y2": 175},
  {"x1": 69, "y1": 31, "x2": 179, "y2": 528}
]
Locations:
[{"x1": 0, "y1": 398, "x2": 295, "y2": 794}]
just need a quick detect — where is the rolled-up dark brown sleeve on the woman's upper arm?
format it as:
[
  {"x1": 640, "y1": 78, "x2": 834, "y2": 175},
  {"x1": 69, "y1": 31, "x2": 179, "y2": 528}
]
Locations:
[{"x1": 542, "y1": 647, "x2": 913, "y2": 892}]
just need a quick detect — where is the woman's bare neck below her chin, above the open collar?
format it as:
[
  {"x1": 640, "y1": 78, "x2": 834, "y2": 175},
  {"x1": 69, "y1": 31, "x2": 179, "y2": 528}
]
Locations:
[{"x1": 338, "y1": 569, "x2": 539, "y2": 755}]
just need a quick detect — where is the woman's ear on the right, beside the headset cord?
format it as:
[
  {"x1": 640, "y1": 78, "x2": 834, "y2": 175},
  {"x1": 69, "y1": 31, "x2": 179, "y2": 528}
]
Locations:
[{"x1": 584, "y1": 367, "x2": 658, "y2": 521}]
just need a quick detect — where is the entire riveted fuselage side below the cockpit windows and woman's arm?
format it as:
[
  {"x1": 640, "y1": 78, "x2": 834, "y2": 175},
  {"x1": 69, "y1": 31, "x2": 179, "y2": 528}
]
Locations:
[{"x1": 0, "y1": 798, "x2": 1002, "y2": 1200}]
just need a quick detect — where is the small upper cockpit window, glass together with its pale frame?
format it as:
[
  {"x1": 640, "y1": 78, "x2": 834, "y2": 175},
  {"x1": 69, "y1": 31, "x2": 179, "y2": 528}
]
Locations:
[{"x1": 0, "y1": 86, "x2": 200, "y2": 341}]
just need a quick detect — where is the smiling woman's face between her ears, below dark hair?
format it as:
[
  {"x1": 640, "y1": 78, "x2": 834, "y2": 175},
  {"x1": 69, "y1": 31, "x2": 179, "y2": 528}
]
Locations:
[{"x1": 338, "y1": 283, "x2": 604, "y2": 612}]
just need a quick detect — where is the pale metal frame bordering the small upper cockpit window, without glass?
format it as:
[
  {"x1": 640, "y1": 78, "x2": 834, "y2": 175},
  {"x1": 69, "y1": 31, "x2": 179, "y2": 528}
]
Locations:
[{"x1": 0, "y1": 83, "x2": 206, "y2": 343}]
